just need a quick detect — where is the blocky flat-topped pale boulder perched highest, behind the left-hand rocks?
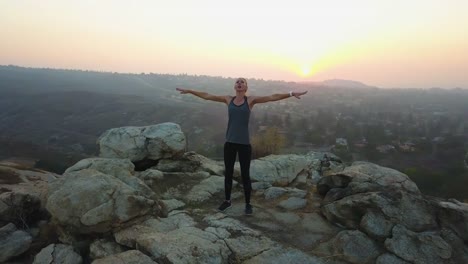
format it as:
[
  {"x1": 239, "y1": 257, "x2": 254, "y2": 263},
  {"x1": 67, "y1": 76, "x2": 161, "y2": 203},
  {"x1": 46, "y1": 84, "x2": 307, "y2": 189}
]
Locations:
[{"x1": 98, "y1": 123, "x2": 187, "y2": 161}]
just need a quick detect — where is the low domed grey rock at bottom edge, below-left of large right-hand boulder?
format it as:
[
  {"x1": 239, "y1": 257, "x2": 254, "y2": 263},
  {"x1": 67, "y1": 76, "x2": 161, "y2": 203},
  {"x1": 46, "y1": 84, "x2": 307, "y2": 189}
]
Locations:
[{"x1": 315, "y1": 230, "x2": 382, "y2": 264}]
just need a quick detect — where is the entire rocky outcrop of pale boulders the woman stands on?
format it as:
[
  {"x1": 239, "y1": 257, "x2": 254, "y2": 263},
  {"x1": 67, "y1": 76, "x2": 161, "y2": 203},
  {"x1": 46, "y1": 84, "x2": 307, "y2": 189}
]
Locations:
[{"x1": 5, "y1": 123, "x2": 468, "y2": 264}]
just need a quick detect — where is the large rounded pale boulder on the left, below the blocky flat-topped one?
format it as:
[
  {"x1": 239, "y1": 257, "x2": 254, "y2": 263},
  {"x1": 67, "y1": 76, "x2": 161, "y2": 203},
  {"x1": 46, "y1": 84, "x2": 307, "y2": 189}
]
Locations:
[{"x1": 46, "y1": 169, "x2": 161, "y2": 233}]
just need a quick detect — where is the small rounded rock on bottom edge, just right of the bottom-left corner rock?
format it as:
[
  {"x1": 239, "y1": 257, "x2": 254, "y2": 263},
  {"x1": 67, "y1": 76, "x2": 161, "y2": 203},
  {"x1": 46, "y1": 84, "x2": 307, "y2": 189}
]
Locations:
[{"x1": 33, "y1": 244, "x2": 83, "y2": 264}]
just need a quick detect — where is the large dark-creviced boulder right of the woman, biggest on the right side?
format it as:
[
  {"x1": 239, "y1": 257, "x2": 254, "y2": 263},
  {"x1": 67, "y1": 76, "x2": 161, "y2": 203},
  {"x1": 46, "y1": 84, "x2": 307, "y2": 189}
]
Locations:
[{"x1": 317, "y1": 162, "x2": 437, "y2": 232}]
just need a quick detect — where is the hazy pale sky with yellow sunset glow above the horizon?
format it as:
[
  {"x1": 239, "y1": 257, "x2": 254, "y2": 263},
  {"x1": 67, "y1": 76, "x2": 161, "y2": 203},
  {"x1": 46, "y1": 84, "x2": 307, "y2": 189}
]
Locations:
[{"x1": 0, "y1": 0, "x2": 468, "y2": 88}]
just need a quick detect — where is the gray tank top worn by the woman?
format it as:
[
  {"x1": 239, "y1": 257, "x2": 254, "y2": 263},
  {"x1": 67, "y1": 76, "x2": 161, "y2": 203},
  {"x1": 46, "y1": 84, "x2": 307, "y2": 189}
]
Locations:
[{"x1": 226, "y1": 96, "x2": 250, "y2": 145}]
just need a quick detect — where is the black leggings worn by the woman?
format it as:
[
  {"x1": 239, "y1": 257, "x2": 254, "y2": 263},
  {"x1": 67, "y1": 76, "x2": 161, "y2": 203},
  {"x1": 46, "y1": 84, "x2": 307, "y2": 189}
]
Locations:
[{"x1": 224, "y1": 142, "x2": 252, "y2": 204}]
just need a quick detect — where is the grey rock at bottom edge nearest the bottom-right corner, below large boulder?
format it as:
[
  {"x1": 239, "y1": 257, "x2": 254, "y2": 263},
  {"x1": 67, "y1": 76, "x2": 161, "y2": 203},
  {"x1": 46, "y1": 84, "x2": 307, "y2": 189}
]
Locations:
[{"x1": 385, "y1": 225, "x2": 454, "y2": 264}]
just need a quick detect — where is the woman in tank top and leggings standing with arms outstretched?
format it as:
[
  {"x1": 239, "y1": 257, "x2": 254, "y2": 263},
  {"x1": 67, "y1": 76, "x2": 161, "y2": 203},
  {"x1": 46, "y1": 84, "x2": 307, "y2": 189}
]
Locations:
[{"x1": 176, "y1": 78, "x2": 307, "y2": 215}]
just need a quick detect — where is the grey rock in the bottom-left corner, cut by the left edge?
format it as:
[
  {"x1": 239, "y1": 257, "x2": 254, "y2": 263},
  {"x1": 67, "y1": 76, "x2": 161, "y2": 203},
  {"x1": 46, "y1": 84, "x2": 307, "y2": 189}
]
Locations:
[{"x1": 0, "y1": 223, "x2": 32, "y2": 263}]
